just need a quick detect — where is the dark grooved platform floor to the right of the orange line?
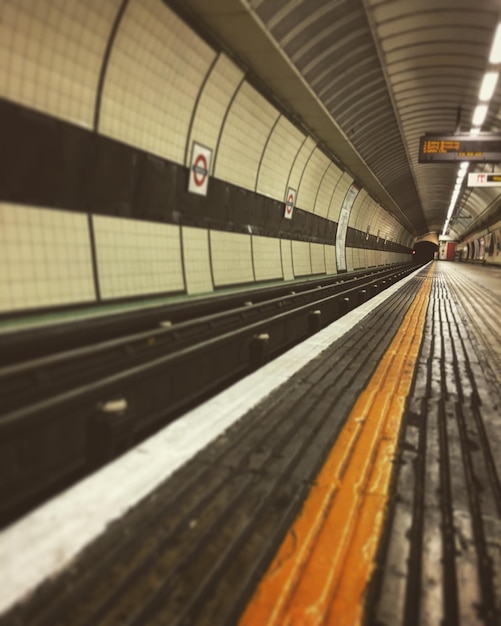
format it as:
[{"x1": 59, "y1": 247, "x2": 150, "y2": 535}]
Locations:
[{"x1": 368, "y1": 264, "x2": 501, "y2": 626}]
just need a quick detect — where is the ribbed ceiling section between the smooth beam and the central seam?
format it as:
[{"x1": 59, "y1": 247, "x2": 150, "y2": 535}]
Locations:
[{"x1": 253, "y1": 0, "x2": 429, "y2": 233}]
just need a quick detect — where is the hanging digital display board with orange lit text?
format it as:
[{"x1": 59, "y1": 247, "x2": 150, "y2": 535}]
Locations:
[{"x1": 418, "y1": 134, "x2": 501, "y2": 163}]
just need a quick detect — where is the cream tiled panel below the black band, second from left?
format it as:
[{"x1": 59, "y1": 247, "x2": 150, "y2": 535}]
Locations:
[{"x1": 93, "y1": 215, "x2": 185, "y2": 299}]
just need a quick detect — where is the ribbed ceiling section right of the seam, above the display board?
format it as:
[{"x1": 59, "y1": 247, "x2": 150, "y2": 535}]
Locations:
[{"x1": 366, "y1": 0, "x2": 500, "y2": 232}]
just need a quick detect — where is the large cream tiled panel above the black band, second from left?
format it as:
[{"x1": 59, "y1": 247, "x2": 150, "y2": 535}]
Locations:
[{"x1": 99, "y1": 0, "x2": 215, "y2": 164}]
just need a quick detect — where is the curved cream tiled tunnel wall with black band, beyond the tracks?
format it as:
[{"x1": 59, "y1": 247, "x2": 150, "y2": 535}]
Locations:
[{"x1": 0, "y1": 0, "x2": 413, "y2": 314}]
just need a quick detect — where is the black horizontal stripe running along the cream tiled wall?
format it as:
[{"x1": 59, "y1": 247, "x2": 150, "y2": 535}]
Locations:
[{"x1": 0, "y1": 99, "x2": 411, "y2": 254}]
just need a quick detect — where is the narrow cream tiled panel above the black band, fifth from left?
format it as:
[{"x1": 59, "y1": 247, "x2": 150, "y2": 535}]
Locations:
[{"x1": 257, "y1": 115, "x2": 304, "y2": 200}]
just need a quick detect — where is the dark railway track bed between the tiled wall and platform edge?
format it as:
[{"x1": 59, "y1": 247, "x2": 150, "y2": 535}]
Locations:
[{"x1": 0, "y1": 265, "x2": 416, "y2": 525}]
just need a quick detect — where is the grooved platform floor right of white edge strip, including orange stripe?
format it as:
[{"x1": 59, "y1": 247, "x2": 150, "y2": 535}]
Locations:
[{"x1": 0, "y1": 262, "x2": 501, "y2": 626}]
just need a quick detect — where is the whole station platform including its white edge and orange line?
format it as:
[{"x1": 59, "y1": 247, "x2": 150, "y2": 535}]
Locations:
[{"x1": 0, "y1": 262, "x2": 501, "y2": 626}]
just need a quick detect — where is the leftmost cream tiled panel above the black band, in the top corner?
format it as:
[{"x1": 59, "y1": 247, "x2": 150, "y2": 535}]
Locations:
[{"x1": 0, "y1": 0, "x2": 121, "y2": 128}]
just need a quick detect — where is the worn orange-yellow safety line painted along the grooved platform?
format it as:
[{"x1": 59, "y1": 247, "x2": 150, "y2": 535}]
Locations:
[{"x1": 240, "y1": 267, "x2": 433, "y2": 626}]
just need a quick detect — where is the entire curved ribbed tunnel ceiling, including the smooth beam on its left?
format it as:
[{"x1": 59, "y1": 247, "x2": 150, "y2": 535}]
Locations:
[{"x1": 183, "y1": 0, "x2": 501, "y2": 238}]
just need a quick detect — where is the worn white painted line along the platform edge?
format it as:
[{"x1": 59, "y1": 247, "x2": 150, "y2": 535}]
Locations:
[{"x1": 0, "y1": 266, "x2": 430, "y2": 615}]
